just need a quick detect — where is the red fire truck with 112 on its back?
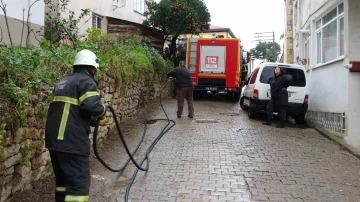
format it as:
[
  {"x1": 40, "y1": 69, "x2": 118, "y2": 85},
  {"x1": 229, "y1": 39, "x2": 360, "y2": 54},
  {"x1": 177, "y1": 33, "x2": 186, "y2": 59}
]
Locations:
[{"x1": 186, "y1": 38, "x2": 241, "y2": 100}]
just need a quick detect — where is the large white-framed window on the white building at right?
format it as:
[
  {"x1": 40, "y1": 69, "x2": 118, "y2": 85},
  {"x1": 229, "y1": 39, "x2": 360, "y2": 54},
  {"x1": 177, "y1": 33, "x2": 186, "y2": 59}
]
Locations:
[{"x1": 315, "y1": 3, "x2": 344, "y2": 64}]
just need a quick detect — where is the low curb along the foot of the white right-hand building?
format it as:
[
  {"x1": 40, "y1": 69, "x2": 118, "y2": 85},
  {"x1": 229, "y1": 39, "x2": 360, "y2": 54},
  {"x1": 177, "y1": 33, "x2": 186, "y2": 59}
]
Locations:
[{"x1": 307, "y1": 123, "x2": 360, "y2": 159}]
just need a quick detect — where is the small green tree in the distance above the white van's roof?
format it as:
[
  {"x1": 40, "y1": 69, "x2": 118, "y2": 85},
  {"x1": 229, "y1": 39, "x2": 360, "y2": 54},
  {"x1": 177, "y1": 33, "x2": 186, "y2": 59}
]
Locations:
[{"x1": 250, "y1": 41, "x2": 281, "y2": 62}]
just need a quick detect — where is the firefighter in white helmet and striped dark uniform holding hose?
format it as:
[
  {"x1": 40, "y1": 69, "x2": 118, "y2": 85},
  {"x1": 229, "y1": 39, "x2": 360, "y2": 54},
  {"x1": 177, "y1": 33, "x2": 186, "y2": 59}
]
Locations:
[{"x1": 45, "y1": 50, "x2": 111, "y2": 202}]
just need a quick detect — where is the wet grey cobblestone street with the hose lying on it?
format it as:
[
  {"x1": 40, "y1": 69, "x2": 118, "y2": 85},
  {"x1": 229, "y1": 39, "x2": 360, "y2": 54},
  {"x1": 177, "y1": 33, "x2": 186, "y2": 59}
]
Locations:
[{"x1": 87, "y1": 95, "x2": 360, "y2": 202}]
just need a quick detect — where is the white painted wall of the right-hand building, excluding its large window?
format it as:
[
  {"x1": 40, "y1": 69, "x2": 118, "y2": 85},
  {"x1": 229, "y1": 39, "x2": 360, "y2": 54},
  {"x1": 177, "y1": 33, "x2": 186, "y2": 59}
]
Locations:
[{"x1": 293, "y1": 0, "x2": 360, "y2": 149}]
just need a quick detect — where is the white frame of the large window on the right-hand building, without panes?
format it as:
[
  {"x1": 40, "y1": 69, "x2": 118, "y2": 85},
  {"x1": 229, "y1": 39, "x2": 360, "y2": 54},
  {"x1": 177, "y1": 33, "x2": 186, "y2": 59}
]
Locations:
[{"x1": 314, "y1": 2, "x2": 345, "y2": 66}]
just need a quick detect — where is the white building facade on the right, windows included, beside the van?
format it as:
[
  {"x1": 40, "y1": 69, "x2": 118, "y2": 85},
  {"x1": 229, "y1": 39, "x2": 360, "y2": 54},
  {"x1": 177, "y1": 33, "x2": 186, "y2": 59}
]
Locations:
[{"x1": 284, "y1": 0, "x2": 360, "y2": 148}]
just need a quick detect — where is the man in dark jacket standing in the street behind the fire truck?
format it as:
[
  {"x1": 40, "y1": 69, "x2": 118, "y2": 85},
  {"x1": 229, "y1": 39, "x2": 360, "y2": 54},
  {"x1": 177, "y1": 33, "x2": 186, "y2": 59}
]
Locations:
[{"x1": 167, "y1": 61, "x2": 194, "y2": 118}]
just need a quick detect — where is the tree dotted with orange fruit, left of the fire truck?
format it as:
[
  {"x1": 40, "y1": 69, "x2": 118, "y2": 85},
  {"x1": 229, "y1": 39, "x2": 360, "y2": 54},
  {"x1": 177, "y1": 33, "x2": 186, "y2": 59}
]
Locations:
[{"x1": 143, "y1": 0, "x2": 211, "y2": 59}]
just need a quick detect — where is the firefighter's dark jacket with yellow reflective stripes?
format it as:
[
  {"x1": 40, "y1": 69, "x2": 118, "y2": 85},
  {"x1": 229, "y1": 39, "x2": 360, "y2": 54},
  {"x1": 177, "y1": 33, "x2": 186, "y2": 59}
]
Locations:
[{"x1": 45, "y1": 70, "x2": 106, "y2": 156}]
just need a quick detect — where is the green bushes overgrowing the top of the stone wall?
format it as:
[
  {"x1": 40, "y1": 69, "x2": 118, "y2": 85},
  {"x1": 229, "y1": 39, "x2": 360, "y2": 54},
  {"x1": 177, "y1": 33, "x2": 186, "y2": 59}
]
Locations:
[{"x1": 0, "y1": 29, "x2": 173, "y2": 155}]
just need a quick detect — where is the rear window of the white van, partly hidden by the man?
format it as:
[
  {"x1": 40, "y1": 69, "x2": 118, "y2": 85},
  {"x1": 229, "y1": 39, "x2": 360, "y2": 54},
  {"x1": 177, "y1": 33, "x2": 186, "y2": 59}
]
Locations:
[{"x1": 260, "y1": 66, "x2": 306, "y2": 87}]
